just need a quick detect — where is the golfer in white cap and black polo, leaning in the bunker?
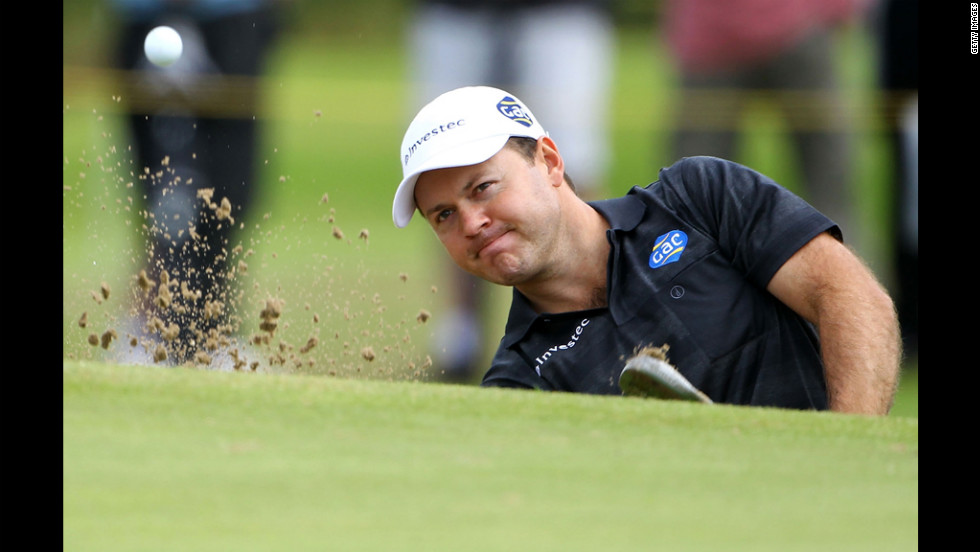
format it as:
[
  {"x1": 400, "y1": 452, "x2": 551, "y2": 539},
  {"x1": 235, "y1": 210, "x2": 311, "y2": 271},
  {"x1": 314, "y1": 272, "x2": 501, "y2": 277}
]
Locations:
[{"x1": 392, "y1": 86, "x2": 901, "y2": 414}]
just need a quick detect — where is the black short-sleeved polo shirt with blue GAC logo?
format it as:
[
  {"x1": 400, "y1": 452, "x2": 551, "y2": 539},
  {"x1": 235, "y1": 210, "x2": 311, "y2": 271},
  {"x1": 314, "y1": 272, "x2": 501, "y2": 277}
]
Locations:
[{"x1": 483, "y1": 157, "x2": 841, "y2": 410}]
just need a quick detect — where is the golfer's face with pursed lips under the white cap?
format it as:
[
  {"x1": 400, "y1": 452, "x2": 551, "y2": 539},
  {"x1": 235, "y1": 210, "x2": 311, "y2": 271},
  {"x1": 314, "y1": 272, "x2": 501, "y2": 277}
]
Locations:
[{"x1": 415, "y1": 144, "x2": 561, "y2": 285}]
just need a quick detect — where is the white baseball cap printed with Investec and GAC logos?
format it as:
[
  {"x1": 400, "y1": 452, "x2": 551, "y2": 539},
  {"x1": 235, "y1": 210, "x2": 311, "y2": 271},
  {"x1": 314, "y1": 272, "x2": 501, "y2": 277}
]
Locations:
[{"x1": 391, "y1": 86, "x2": 548, "y2": 228}]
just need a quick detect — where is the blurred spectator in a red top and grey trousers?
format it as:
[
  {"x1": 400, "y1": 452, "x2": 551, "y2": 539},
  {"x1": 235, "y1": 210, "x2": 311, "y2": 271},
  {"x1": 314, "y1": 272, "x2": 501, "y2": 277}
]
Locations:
[{"x1": 662, "y1": 0, "x2": 870, "y2": 250}]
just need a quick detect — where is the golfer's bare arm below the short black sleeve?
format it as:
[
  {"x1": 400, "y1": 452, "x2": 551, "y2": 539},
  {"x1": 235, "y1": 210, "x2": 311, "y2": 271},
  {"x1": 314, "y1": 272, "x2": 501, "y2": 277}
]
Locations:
[{"x1": 767, "y1": 232, "x2": 902, "y2": 415}]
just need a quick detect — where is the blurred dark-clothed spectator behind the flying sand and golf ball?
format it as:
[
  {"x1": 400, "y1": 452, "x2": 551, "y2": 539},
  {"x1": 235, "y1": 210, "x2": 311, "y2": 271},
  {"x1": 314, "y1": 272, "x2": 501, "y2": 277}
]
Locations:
[{"x1": 111, "y1": 0, "x2": 280, "y2": 364}]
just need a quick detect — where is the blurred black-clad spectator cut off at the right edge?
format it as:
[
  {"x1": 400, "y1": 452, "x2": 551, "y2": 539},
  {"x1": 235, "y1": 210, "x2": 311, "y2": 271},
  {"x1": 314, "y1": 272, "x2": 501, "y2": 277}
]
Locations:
[{"x1": 876, "y1": 0, "x2": 919, "y2": 355}]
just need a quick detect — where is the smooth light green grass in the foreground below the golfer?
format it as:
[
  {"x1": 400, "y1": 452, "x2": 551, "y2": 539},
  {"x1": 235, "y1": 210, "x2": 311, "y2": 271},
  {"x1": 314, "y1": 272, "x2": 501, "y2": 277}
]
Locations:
[{"x1": 63, "y1": 360, "x2": 918, "y2": 552}]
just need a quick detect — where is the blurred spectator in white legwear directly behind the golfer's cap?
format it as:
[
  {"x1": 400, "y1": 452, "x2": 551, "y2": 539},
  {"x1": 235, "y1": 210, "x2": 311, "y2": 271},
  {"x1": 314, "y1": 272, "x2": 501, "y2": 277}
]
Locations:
[{"x1": 408, "y1": 0, "x2": 615, "y2": 382}]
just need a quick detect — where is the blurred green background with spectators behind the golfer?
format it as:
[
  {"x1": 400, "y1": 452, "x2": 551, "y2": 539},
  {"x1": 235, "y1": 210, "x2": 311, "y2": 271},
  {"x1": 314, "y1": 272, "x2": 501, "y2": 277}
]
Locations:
[{"x1": 62, "y1": 0, "x2": 918, "y2": 382}]
